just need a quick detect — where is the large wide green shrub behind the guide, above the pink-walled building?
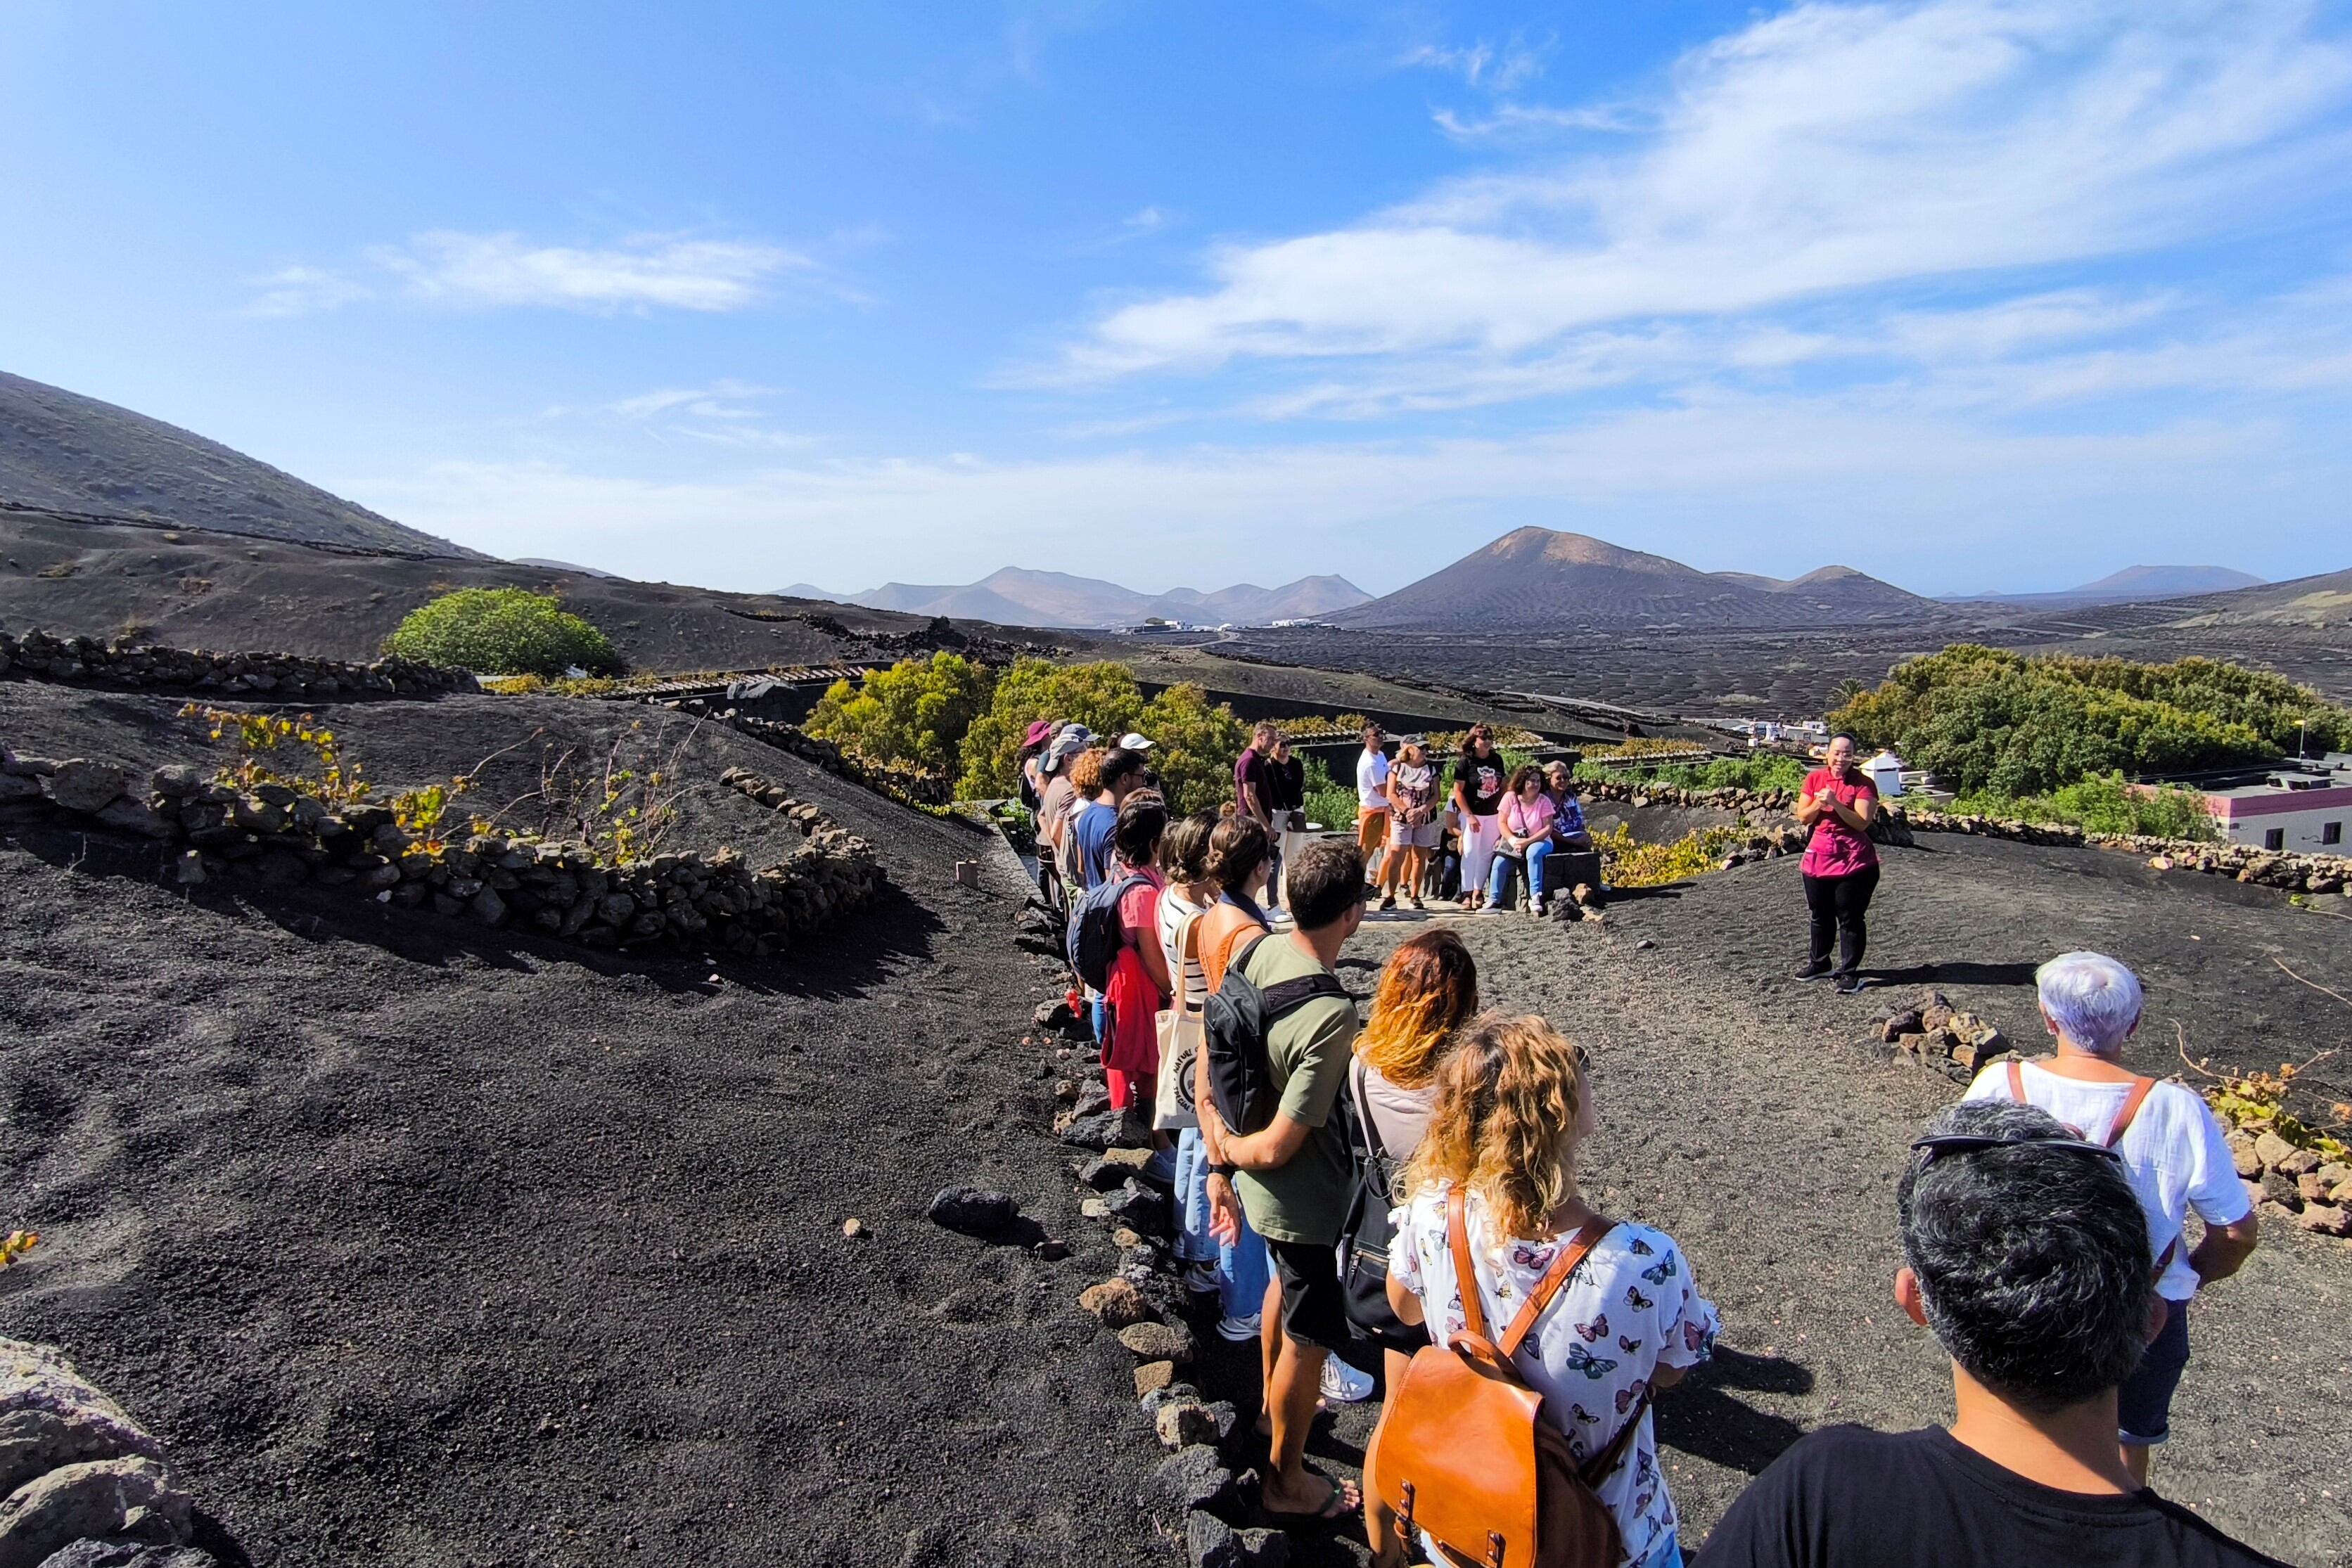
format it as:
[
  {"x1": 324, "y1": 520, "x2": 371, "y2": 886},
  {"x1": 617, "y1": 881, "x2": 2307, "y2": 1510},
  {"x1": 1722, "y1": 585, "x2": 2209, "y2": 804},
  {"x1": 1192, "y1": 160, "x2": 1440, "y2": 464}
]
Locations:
[{"x1": 1830, "y1": 644, "x2": 2352, "y2": 799}]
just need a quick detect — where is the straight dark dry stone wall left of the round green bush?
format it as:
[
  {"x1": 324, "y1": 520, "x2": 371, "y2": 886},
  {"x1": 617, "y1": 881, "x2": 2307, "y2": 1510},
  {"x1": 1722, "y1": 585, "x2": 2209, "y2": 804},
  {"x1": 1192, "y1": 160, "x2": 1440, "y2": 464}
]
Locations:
[{"x1": 0, "y1": 630, "x2": 478, "y2": 703}]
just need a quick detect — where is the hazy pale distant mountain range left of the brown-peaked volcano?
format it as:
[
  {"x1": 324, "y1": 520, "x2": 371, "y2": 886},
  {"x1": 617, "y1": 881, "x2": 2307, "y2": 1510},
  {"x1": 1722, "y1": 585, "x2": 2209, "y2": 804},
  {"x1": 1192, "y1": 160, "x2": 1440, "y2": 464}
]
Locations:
[{"x1": 784, "y1": 567, "x2": 1372, "y2": 628}]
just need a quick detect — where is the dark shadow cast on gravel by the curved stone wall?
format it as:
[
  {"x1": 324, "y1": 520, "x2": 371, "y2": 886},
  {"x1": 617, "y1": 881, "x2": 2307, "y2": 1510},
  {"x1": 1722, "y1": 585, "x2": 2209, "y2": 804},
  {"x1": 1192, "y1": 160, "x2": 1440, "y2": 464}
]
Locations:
[{"x1": 0, "y1": 821, "x2": 945, "y2": 1001}]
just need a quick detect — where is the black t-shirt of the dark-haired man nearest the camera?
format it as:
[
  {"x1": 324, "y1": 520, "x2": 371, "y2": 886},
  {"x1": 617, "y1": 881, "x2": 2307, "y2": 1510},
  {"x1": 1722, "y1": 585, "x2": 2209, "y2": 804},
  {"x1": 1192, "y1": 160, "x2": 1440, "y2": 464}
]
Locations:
[{"x1": 1691, "y1": 1427, "x2": 2284, "y2": 1568}]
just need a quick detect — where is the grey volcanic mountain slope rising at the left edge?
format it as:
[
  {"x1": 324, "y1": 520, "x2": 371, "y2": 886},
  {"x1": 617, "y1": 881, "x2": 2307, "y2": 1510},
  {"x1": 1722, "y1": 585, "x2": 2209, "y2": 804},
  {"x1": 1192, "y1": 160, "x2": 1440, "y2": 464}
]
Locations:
[{"x1": 0, "y1": 371, "x2": 487, "y2": 560}]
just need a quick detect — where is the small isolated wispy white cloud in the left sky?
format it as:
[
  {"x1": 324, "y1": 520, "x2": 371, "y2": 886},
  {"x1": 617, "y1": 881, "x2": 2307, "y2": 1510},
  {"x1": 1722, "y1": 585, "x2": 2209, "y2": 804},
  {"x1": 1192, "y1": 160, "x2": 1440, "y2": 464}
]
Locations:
[{"x1": 245, "y1": 228, "x2": 821, "y2": 315}]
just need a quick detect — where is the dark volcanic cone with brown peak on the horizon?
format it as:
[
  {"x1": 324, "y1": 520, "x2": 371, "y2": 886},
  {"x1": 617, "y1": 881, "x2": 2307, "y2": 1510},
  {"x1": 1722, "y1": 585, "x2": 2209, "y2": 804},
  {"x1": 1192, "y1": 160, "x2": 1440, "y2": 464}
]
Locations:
[{"x1": 1331, "y1": 529, "x2": 1950, "y2": 630}]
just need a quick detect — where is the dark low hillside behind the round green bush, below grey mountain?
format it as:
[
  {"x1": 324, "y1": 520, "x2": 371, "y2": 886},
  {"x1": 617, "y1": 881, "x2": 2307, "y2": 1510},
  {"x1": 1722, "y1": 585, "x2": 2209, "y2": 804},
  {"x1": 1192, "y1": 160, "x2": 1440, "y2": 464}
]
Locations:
[{"x1": 0, "y1": 513, "x2": 1068, "y2": 670}]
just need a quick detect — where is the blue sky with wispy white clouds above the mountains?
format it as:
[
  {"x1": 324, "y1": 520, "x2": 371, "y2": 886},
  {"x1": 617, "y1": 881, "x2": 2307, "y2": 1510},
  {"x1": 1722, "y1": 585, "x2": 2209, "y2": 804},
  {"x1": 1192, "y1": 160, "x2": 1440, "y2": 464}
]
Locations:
[{"x1": 0, "y1": 0, "x2": 2352, "y2": 593}]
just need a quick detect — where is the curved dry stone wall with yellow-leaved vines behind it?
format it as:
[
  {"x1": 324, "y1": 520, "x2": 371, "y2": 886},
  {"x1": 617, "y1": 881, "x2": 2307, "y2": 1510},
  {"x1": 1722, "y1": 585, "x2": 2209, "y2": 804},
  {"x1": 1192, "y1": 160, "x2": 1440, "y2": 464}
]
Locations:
[{"x1": 0, "y1": 745, "x2": 882, "y2": 954}]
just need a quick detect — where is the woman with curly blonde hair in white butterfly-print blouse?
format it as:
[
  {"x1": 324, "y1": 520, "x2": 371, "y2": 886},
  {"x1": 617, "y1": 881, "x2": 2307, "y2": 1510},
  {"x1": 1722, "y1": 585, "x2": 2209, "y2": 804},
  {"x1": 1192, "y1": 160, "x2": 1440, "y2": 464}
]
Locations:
[{"x1": 1374, "y1": 1013, "x2": 1717, "y2": 1568}]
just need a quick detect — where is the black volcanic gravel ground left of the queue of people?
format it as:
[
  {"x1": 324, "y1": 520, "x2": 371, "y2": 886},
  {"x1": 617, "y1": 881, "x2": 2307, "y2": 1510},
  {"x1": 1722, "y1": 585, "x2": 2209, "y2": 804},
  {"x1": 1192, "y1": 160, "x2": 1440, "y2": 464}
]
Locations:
[{"x1": 0, "y1": 686, "x2": 1167, "y2": 1566}]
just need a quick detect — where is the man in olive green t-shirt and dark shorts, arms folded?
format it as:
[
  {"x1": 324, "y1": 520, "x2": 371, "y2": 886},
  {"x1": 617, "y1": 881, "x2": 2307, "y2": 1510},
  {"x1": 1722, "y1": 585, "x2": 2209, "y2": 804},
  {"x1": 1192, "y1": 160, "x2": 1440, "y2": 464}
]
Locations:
[{"x1": 1202, "y1": 840, "x2": 1364, "y2": 1523}]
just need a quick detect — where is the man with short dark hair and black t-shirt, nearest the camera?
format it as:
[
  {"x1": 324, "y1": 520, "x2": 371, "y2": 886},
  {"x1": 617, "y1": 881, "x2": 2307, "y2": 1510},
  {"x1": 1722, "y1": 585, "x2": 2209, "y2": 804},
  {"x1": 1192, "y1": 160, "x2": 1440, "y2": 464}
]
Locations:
[{"x1": 1696, "y1": 1100, "x2": 2272, "y2": 1568}]
